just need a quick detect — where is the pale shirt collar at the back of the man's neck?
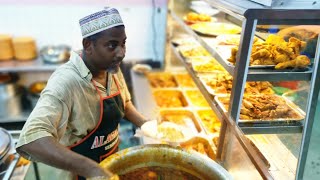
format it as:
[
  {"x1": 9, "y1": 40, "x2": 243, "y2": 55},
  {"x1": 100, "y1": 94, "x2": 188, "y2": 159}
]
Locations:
[{"x1": 70, "y1": 51, "x2": 92, "y2": 81}]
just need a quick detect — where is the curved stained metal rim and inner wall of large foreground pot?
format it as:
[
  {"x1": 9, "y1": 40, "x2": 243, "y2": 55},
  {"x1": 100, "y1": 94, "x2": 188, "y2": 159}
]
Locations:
[{"x1": 100, "y1": 144, "x2": 232, "y2": 180}]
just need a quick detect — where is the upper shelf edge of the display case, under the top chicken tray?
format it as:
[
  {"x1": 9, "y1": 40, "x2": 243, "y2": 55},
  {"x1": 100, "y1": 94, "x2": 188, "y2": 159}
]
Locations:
[{"x1": 170, "y1": 11, "x2": 312, "y2": 81}]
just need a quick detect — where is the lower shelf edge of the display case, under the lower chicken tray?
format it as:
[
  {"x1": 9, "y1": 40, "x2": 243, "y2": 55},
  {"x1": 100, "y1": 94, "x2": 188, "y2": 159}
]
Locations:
[{"x1": 171, "y1": 45, "x2": 303, "y2": 134}]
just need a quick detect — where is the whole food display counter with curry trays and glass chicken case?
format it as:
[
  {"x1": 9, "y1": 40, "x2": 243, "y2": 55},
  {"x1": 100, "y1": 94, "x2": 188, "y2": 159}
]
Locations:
[{"x1": 131, "y1": 0, "x2": 320, "y2": 179}]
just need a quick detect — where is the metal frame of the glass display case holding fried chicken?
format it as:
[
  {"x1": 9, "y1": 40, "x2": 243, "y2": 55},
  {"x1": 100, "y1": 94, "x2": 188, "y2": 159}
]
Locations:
[{"x1": 169, "y1": 0, "x2": 320, "y2": 179}]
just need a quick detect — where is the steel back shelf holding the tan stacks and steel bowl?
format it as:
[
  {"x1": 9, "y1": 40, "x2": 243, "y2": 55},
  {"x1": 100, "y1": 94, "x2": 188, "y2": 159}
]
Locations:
[{"x1": 0, "y1": 58, "x2": 61, "y2": 72}]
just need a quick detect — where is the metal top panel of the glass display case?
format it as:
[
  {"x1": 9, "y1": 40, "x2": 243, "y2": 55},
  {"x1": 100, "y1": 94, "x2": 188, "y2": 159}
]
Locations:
[{"x1": 205, "y1": 0, "x2": 320, "y2": 20}]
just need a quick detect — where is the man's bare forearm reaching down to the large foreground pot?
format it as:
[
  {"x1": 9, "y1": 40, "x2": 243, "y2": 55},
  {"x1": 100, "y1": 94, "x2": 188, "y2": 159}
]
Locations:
[{"x1": 17, "y1": 137, "x2": 111, "y2": 177}]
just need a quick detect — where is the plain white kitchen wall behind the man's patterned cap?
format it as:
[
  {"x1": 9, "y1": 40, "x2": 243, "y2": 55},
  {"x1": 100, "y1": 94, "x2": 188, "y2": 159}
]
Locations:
[{"x1": 0, "y1": 0, "x2": 167, "y2": 61}]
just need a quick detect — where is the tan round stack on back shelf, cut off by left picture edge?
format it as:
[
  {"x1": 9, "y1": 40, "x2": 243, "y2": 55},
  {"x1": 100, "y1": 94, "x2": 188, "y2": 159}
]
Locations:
[{"x1": 0, "y1": 35, "x2": 13, "y2": 61}]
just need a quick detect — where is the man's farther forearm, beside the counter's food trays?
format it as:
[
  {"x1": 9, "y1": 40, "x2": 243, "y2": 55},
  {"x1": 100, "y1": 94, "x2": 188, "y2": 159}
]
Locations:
[{"x1": 125, "y1": 101, "x2": 147, "y2": 127}]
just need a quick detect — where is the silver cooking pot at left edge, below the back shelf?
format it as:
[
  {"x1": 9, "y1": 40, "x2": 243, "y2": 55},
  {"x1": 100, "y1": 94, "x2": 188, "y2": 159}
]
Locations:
[{"x1": 0, "y1": 74, "x2": 23, "y2": 117}]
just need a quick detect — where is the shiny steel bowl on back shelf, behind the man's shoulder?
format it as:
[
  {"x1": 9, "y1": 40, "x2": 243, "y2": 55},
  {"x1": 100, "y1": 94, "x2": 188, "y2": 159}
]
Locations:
[{"x1": 40, "y1": 45, "x2": 71, "y2": 64}]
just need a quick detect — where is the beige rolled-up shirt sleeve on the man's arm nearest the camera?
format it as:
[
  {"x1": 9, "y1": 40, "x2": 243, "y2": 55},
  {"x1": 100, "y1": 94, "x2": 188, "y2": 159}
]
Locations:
[{"x1": 16, "y1": 92, "x2": 70, "y2": 153}]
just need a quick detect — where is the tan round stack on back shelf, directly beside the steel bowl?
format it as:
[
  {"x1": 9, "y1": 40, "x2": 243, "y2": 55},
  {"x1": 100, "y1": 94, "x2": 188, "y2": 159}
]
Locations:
[{"x1": 13, "y1": 37, "x2": 37, "y2": 61}]
